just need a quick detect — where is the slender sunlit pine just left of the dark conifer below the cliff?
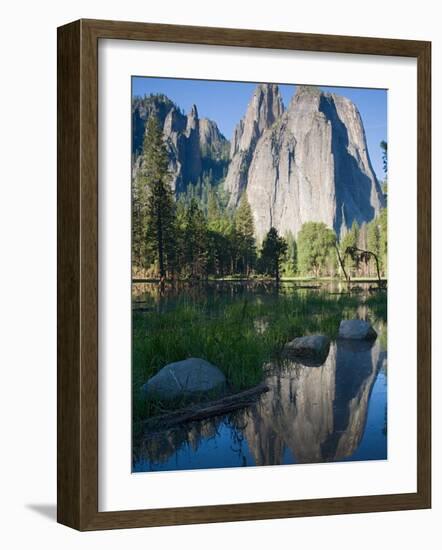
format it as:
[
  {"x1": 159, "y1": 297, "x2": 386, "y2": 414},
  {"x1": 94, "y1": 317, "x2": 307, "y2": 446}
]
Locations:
[{"x1": 235, "y1": 193, "x2": 256, "y2": 276}]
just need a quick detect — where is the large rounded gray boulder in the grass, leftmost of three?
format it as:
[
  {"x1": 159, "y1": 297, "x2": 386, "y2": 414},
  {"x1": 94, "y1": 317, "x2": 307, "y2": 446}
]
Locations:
[{"x1": 141, "y1": 357, "x2": 226, "y2": 401}]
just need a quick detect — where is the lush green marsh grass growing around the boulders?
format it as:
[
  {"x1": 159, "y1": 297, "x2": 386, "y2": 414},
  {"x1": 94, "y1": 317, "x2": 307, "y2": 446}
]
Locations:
[{"x1": 133, "y1": 292, "x2": 386, "y2": 424}]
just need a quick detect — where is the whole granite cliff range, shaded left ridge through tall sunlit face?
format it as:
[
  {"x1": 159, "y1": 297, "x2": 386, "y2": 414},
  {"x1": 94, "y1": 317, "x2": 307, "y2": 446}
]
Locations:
[{"x1": 132, "y1": 84, "x2": 385, "y2": 241}]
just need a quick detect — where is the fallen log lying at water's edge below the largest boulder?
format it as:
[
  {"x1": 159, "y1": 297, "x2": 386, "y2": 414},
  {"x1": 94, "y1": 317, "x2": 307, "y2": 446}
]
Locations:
[{"x1": 143, "y1": 383, "x2": 269, "y2": 433}]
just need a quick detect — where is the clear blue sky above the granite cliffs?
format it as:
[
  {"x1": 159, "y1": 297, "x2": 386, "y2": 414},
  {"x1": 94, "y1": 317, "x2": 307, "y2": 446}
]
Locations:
[{"x1": 132, "y1": 76, "x2": 387, "y2": 180}]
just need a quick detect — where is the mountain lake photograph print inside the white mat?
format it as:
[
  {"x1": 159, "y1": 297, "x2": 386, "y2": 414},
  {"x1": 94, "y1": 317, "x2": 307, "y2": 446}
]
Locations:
[{"x1": 131, "y1": 74, "x2": 388, "y2": 473}]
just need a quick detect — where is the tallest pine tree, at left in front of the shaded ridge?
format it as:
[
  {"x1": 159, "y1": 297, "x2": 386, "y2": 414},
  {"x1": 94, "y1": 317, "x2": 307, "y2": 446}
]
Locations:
[{"x1": 142, "y1": 116, "x2": 175, "y2": 278}]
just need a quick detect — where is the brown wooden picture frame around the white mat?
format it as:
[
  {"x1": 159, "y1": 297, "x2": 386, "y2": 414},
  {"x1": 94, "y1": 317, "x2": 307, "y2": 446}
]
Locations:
[{"x1": 57, "y1": 20, "x2": 431, "y2": 531}]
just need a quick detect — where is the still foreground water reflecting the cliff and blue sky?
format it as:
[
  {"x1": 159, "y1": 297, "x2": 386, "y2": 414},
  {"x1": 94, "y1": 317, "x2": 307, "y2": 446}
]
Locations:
[{"x1": 134, "y1": 339, "x2": 387, "y2": 471}]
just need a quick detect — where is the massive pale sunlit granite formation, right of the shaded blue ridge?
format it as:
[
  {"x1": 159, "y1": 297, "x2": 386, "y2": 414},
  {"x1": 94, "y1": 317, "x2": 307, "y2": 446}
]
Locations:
[{"x1": 225, "y1": 85, "x2": 385, "y2": 240}]
